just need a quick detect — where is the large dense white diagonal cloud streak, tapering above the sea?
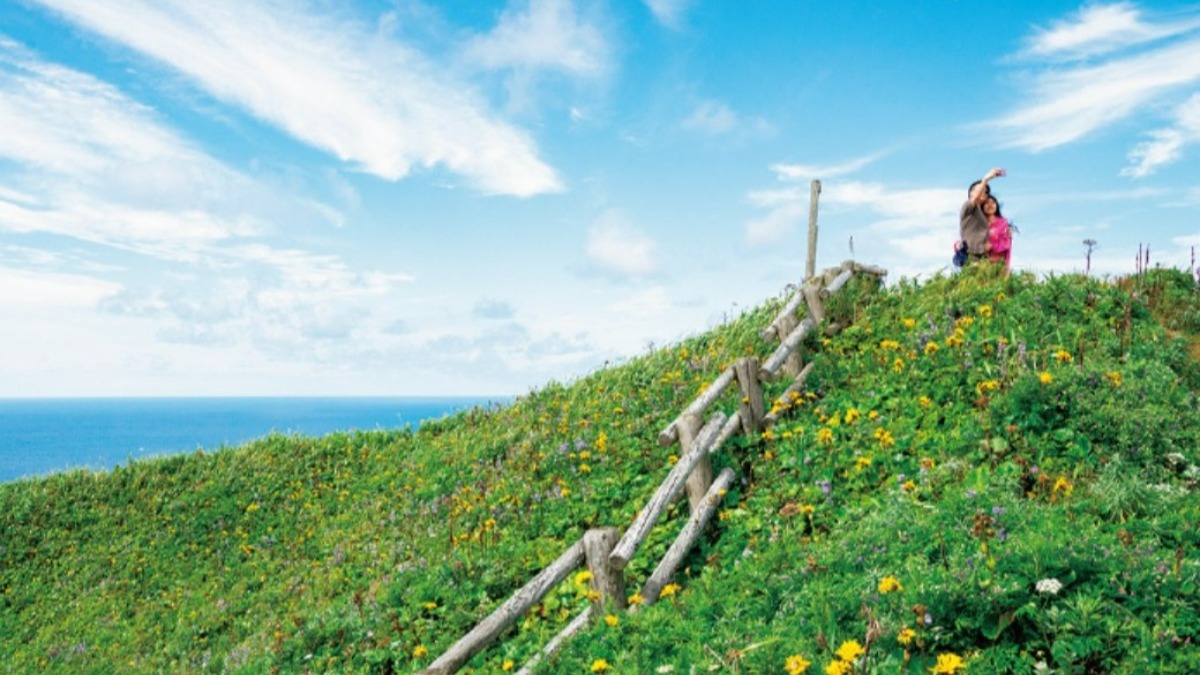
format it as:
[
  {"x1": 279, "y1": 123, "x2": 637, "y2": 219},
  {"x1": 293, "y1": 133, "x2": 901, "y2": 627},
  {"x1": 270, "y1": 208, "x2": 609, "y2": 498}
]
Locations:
[{"x1": 28, "y1": 0, "x2": 562, "y2": 196}]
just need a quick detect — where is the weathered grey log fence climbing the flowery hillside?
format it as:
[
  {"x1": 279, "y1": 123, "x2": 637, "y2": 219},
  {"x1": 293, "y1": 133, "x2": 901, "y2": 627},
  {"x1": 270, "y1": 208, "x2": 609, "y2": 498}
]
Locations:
[{"x1": 420, "y1": 258, "x2": 887, "y2": 675}]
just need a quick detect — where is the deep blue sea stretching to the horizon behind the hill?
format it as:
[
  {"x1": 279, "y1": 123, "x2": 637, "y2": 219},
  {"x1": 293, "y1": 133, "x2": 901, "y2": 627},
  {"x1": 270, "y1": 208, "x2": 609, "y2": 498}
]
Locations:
[{"x1": 0, "y1": 398, "x2": 496, "y2": 482}]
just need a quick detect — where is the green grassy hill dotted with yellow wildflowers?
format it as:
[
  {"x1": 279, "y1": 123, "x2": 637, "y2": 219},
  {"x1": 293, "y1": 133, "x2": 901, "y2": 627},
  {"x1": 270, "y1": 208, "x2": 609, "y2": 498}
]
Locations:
[{"x1": 0, "y1": 263, "x2": 1200, "y2": 674}]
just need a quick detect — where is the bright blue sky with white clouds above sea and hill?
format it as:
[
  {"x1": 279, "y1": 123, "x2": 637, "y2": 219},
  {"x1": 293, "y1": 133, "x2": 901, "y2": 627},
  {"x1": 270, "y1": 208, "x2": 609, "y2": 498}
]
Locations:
[{"x1": 0, "y1": 0, "x2": 1200, "y2": 396}]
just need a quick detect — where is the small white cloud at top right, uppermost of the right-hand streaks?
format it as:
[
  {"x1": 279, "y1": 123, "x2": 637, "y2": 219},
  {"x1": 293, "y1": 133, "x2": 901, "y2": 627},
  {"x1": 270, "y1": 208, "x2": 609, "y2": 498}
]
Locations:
[{"x1": 1025, "y1": 2, "x2": 1200, "y2": 58}]
